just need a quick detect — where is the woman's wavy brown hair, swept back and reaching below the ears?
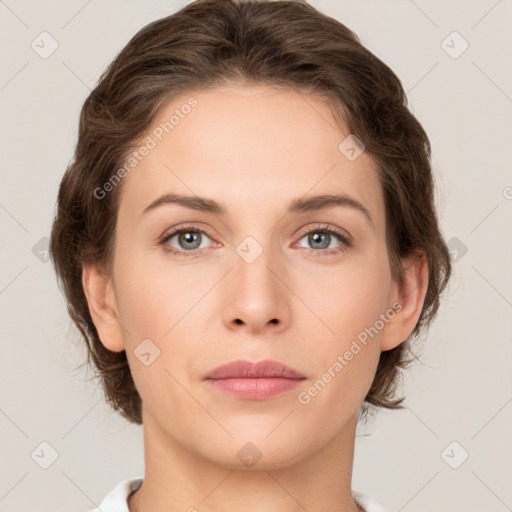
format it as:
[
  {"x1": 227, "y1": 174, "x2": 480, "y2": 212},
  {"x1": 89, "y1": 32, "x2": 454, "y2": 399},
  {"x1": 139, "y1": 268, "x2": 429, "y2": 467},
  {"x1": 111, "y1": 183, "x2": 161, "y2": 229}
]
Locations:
[{"x1": 50, "y1": 0, "x2": 451, "y2": 424}]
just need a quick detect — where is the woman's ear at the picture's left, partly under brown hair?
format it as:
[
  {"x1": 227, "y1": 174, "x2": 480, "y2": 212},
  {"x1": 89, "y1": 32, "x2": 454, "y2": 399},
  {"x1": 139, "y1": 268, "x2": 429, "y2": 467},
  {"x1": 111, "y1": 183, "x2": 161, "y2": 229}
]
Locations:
[{"x1": 82, "y1": 263, "x2": 125, "y2": 352}]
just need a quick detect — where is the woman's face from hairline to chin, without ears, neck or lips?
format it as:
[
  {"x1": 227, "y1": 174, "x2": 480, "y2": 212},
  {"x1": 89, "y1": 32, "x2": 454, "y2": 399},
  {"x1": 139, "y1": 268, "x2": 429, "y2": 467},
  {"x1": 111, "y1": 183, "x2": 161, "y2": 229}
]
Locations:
[{"x1": 102, "y1": 85, "x2": 399, "y2": 468}]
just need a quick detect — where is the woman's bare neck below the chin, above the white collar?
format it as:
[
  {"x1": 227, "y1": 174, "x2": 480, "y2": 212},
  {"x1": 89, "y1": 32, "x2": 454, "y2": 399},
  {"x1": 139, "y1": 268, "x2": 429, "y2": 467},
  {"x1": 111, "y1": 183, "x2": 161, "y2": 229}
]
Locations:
[{"x1": 128, "y1": 412, "x2": 362, "y2": 512}]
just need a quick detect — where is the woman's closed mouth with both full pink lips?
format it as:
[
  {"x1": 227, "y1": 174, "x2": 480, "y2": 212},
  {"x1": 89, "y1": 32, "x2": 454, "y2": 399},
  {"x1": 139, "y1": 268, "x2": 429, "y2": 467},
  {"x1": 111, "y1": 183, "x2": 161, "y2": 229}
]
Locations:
[{"x1": 204, "y1": 360, "x2": 306, "y2": 400}]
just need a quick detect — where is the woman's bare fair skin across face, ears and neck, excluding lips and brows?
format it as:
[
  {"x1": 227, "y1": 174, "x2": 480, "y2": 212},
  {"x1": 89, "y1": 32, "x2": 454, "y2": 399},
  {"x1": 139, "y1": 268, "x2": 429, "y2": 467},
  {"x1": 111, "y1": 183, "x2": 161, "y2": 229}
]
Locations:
[{"x1": 83, "y1": 84, "x2": 427, "y2": 512}]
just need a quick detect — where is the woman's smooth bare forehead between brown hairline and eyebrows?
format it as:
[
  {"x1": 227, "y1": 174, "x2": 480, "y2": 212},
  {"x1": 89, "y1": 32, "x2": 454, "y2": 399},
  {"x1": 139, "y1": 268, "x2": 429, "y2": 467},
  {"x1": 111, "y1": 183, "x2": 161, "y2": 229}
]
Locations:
[{"x1": 120, "y1": 85, "x2": 383, "y2": 232}]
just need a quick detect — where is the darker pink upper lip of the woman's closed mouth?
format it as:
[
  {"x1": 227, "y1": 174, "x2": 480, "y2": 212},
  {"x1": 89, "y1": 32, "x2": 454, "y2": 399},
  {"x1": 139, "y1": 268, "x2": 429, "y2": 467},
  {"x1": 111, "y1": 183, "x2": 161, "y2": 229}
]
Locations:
[{"x1": 205, "y1": 359, "x2": 306, "y2": 379}]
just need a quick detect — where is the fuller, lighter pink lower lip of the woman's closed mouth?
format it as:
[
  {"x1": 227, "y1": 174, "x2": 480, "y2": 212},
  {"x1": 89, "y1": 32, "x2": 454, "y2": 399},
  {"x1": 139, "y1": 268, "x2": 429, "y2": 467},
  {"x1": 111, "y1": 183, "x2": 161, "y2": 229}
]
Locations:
[{"x1": 207, "y1": 377, "x2": 304, "y2": 400}]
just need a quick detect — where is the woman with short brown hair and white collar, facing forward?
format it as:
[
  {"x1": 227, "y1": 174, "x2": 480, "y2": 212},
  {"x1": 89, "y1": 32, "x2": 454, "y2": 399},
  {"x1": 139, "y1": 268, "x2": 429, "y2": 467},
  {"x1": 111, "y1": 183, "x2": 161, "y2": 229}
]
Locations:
[{"x1": 50, "y1": 0, "x2": 451, "y2": 512}]
